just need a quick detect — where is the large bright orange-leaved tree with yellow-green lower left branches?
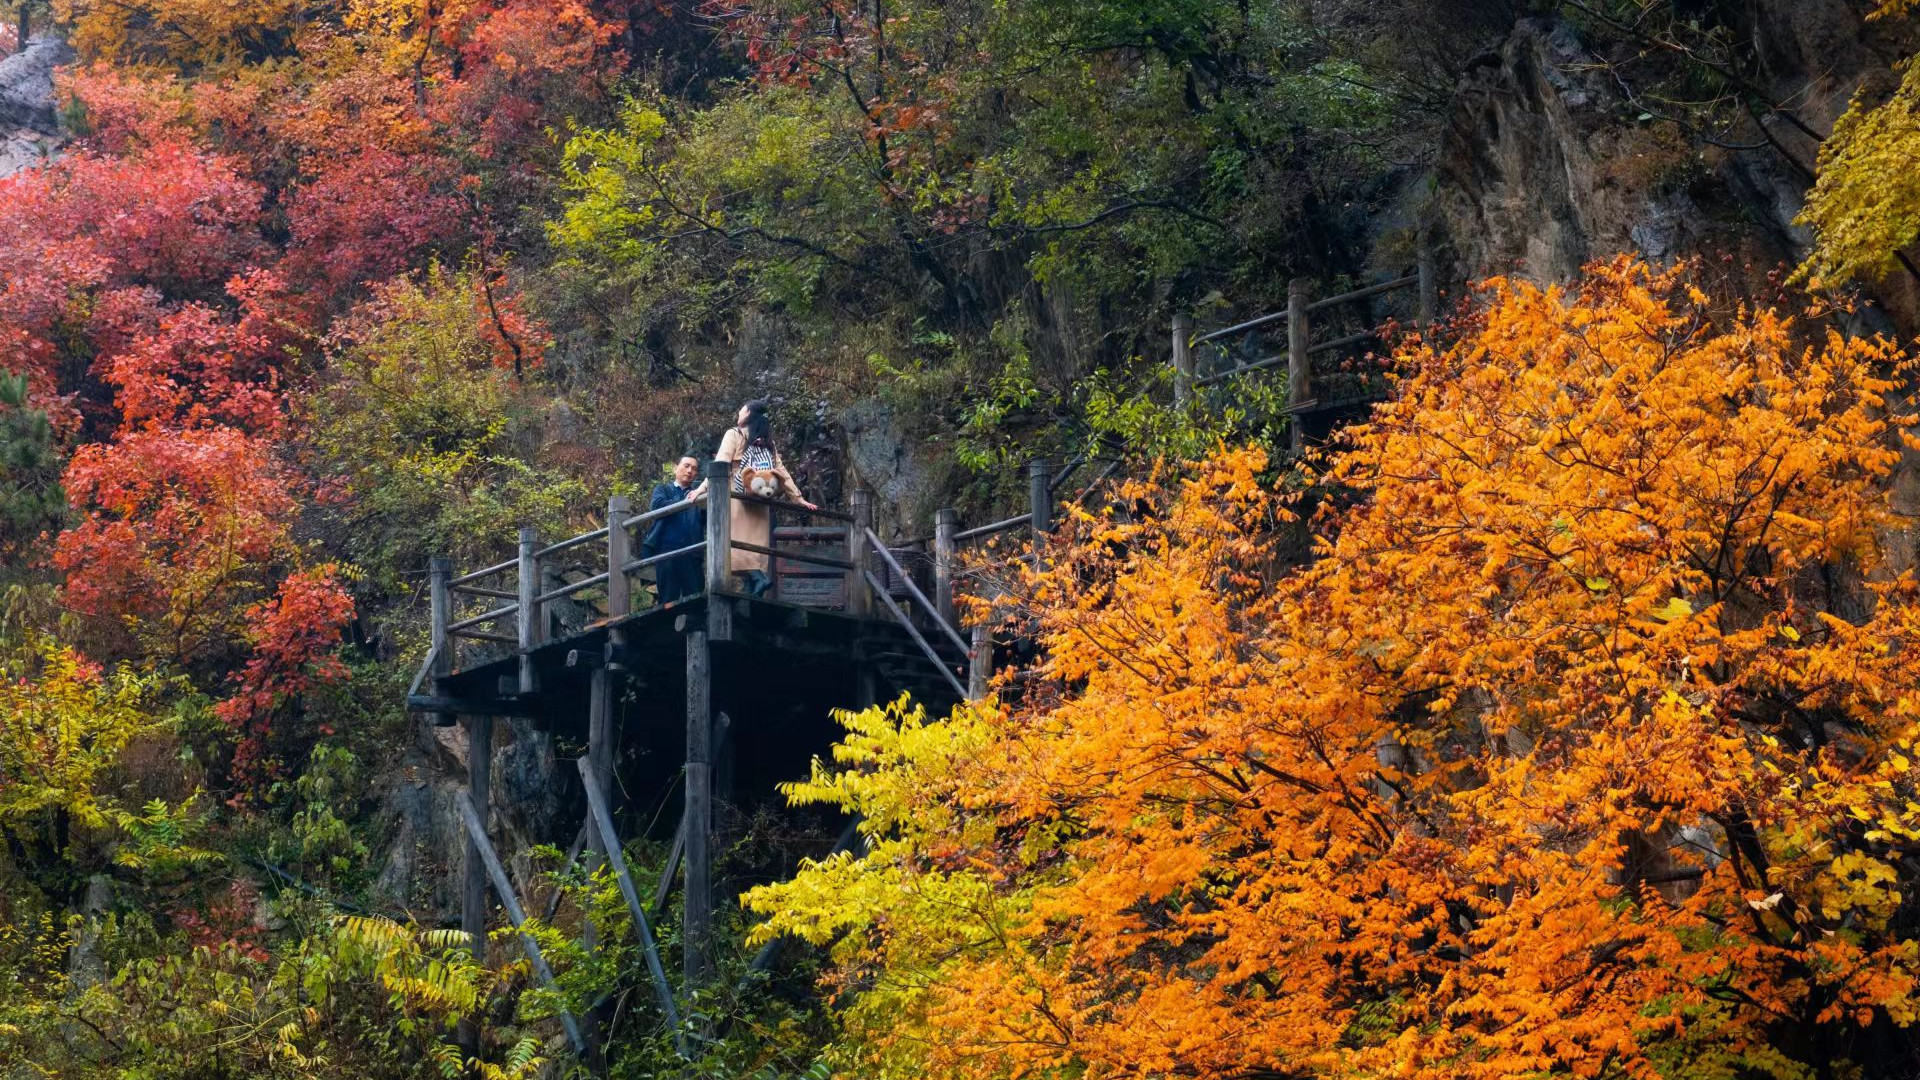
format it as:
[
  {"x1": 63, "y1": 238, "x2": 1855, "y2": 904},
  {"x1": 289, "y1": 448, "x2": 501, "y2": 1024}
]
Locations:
[{"x1": 747, "y1": 261, "x2": 1920, "y2": 1080}]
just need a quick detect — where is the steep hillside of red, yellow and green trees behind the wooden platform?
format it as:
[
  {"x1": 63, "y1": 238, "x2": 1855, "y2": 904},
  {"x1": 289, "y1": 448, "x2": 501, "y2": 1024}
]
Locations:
[{"x1": 0, "y1": 0, "x2": 1920, "y2": 1080}]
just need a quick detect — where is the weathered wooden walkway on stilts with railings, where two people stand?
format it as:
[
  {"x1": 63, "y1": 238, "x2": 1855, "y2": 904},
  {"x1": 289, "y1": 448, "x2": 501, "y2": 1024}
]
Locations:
[{"x1": 407, "y1": 256, "x2": 1436, "y2": 1061}]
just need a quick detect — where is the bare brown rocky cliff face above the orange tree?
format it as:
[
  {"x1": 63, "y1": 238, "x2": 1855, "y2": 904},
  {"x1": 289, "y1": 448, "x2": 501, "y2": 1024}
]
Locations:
[{"x1": 1432, "y1": 0, "x2": 1910, "y2": 306}]
